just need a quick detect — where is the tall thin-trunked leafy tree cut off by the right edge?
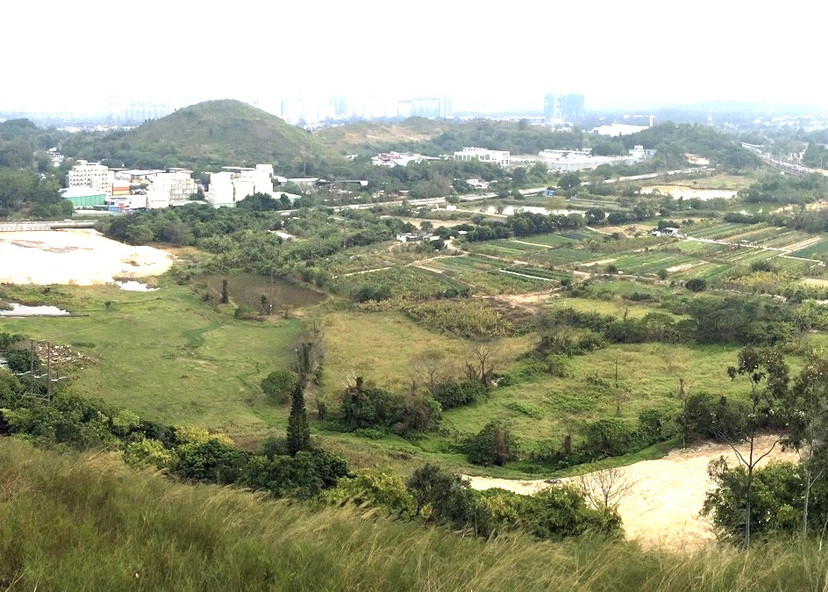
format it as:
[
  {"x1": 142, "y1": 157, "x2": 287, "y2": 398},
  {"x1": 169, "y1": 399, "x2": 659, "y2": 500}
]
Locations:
[{"x1": 784, "y1": 358, "x2": 828, "y2": 537}]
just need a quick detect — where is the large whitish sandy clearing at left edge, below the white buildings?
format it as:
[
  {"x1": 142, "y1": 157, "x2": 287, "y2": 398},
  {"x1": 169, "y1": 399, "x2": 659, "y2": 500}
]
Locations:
[{"x1": 0, "y1": 229, "x2": 173, "y2": 286}]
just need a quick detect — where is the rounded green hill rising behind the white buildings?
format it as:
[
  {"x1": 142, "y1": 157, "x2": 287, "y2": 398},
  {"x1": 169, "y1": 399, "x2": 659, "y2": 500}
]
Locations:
[{"x1": 64, "y1": 100, "x2": 336, "y2": 168}]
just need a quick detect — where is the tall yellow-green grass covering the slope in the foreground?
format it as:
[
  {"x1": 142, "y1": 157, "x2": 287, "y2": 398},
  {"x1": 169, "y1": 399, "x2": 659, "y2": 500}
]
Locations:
[{"x1": 0, "y1": 438, "x2": 828, "y2": 592}]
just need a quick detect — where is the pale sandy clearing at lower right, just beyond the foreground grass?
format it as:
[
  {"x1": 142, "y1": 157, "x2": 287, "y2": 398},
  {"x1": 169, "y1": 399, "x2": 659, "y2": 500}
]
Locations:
[{"x1": 467, "y1": 436, "x2": 798, "y2": 548}]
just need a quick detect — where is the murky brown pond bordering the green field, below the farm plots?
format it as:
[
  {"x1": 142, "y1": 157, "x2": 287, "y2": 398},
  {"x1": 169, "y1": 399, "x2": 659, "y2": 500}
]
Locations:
[{"x1": 196, "y1": 273, "x2": 327, "y2": 311}]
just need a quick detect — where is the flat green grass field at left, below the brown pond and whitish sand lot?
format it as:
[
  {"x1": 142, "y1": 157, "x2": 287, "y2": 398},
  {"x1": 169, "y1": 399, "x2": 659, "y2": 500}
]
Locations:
[{"x1": 0, "y1": 282, "x2": 300, "y2": 435}]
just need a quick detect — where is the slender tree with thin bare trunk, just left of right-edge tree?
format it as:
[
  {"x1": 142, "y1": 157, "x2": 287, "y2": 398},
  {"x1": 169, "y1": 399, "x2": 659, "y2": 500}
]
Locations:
[{"x1": 724, "y1": 347, "x2": 788, "y2": 546}]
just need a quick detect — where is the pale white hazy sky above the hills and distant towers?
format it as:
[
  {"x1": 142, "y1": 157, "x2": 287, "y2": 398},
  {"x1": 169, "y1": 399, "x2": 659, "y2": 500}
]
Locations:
[{"x1": 6, "y1": 0, "x2": 828, "y2": 111}]
